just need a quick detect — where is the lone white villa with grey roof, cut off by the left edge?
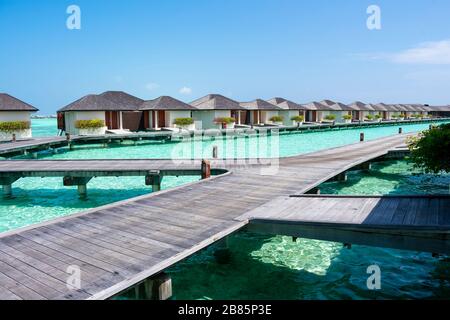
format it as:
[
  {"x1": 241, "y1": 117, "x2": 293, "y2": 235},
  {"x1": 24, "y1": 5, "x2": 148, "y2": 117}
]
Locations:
[{"x1": 0, "y1": 93, "x2": 39, "y2": 141}]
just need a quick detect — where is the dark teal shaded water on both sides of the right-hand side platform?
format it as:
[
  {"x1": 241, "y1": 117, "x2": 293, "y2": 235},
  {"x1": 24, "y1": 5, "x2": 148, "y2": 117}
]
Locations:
[{"x1": 163, "y1": 161, "x2": 450, "y2": 300}]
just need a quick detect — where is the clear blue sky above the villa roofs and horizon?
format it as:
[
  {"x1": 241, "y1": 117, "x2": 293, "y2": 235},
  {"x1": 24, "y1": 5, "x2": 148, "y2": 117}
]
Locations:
[{"x1": 0, "y1": 0, "x2": 450, "y2": 114}]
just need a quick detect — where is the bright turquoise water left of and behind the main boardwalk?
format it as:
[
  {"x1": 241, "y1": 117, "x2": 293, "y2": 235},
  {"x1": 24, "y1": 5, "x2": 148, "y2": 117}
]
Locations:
[{"x1": 0, "y1": 119, "x2": 450, "y2": 232}]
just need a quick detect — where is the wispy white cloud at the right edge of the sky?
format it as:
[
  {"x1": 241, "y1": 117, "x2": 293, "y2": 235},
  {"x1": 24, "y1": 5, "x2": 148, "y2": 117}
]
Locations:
[{"x1": 390, "y1": 40, "x2": 450, "y2": 65}]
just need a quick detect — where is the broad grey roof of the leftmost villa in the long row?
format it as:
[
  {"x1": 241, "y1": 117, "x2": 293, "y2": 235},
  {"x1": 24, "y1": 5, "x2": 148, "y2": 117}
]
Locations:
[{"x1": 58, "y1": 91, "x2": 144, "y2": 112}]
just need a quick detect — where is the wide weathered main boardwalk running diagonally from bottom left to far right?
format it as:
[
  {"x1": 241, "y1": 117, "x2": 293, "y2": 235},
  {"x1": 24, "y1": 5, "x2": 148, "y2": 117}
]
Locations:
[{"x1": 0, "y1": 135, "x2": 446, "y2": 299}]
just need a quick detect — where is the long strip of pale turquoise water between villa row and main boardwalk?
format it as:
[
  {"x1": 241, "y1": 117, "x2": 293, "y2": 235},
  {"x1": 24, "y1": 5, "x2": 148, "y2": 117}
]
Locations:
[{"x1": 32, "y1": 120, "x2": 450, "y2": 159}]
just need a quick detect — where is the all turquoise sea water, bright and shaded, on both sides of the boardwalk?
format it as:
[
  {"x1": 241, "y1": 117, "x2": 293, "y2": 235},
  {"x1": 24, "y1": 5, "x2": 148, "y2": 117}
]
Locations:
[{"x1": 0, "y1": 120, "x2": 450, "y2": 299}]
